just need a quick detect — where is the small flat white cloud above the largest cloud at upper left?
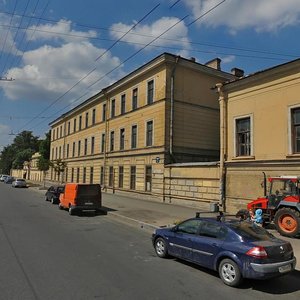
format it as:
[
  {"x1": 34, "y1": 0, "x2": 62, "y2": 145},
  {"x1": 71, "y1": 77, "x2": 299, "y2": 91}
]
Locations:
[{"x1": 27, "y1": 20, "x2": 97, "y2": 42}]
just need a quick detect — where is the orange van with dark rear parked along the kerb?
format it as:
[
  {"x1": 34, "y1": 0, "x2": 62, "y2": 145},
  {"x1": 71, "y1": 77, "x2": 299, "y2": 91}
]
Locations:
[{"x1": 58, "y1": 183, "x2": 102, "y2": 215}]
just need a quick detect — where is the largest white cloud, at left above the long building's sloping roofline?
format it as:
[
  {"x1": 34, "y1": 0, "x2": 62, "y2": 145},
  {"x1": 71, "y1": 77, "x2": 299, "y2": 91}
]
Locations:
[{"x1": 3, "y1": 41, "x2": 120, "y2": 101}]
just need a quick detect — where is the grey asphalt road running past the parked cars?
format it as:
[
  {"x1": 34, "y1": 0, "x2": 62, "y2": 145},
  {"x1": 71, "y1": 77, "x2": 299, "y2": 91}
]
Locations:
[{"x1": 0, "y1": 183, "x2": 300, "y2": 300}]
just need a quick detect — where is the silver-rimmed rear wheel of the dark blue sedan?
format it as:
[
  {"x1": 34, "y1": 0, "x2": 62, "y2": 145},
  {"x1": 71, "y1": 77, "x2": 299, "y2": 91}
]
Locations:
[{"x1": 219, "y1": 258, "x2": 242, "y2": 286}]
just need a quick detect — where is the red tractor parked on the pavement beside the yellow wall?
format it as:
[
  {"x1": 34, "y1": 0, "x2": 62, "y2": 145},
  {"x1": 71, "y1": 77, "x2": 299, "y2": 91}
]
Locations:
[{"x1": 247, "y1": 172, "x2": 300, "y2": 237}]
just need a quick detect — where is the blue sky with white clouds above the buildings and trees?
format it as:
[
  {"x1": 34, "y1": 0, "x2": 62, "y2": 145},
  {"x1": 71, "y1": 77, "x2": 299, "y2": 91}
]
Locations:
[{"x1": 0, "y1": 0, "x2": 300, "y2": 151}]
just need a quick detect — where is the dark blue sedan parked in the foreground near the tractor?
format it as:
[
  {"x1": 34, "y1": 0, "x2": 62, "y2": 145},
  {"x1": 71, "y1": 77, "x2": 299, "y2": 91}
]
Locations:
[{"x1": 152, "y1": 217, "x2": 296, "y2": 286}]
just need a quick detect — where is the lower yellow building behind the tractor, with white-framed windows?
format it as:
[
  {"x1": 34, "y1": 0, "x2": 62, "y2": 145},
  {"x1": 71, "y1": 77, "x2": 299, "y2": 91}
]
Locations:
[{"x1": 217, "y1": 59, "x2": 300, "y2": 212}]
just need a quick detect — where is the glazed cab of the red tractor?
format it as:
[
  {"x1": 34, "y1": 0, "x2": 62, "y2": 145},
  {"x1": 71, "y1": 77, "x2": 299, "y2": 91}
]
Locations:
[{"x1": 266, "y1": 176, "x2": 300, "y2": 209}]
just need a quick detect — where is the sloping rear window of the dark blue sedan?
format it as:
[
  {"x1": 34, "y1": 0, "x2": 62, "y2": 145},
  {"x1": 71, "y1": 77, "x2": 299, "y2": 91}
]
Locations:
[{"x1": 229, "y1": 222, "x2": 274, "y2": 241}]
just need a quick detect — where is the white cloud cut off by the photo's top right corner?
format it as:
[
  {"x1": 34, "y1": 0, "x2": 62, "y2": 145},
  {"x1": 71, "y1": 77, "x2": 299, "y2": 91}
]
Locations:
[{"x1": 184, "y1": 0, "x2": 300, "y2": 33}]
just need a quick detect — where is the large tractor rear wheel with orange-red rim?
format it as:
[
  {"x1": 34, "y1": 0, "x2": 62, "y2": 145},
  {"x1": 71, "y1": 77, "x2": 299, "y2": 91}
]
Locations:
[{"x1": 274, "y1": 207, "x2": 300, "y2": 237}]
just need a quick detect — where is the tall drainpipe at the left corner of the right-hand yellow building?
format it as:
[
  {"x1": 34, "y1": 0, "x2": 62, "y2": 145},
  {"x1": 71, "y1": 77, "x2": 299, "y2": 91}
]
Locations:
[{"x1": 216, "y1": 83, "x2": 227, "y2": 211}]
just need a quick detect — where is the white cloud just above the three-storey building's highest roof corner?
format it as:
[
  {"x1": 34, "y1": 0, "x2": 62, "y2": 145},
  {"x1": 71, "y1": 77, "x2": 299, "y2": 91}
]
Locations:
[{"x1": 110, "y1": 17, "x2": 189, "y2": 49}]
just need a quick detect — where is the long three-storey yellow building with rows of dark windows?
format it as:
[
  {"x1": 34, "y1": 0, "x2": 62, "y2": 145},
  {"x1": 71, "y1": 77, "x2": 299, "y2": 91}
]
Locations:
[{"x1": 50, "y1": 53, "x2": 235, "y2": 202}]
